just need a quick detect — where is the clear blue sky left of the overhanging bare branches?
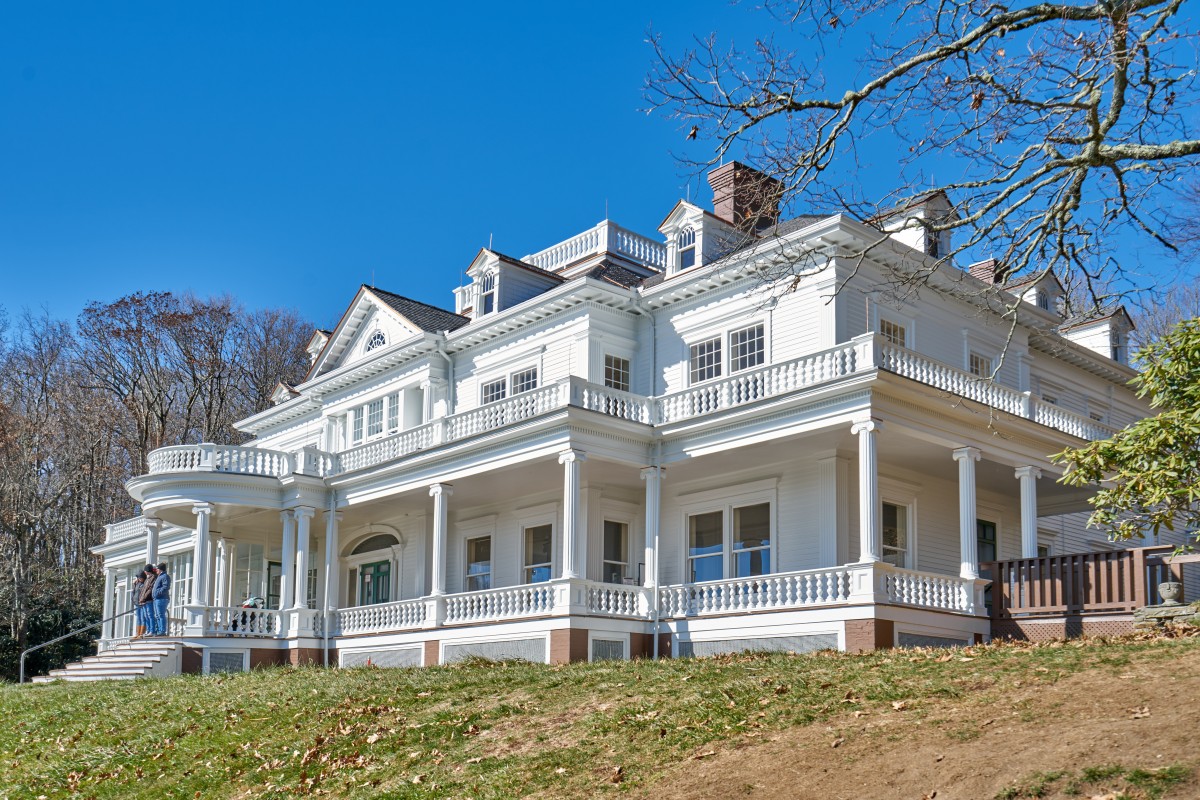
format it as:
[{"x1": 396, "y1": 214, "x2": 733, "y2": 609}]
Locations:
[{"x1": 0, "y1": 1, "x2": 796, "y2": 325}]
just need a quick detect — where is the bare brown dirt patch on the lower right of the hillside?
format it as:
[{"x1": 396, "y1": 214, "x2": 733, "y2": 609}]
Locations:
[{"x1": 646, "y1": 651, "x2": 1200, "y2": 800}]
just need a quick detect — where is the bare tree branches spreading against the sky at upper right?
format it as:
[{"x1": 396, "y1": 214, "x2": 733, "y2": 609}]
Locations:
[{"x1": 646, "y1": 0, "x2": 1200, "y2": 305}]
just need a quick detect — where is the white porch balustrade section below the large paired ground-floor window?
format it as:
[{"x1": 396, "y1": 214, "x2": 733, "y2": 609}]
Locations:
[{"x1": 659, "y1": 566, "x2": 850, "y2": 619}]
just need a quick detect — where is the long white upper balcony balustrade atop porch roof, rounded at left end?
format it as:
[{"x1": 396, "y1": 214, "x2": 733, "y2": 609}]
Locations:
[{"x1": 136, "y1": 333, "x2": 1116, "y2": 489}]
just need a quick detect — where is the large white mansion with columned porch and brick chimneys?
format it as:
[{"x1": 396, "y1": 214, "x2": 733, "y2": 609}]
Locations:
[{"x1": 87, "y1": 163, "x2": 1147, "y2": 672}]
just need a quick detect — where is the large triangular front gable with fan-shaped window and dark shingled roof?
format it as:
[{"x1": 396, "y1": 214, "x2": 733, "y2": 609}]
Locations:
[{"x1": 307, "y1": 284, "x2": 470, "y2": 380}]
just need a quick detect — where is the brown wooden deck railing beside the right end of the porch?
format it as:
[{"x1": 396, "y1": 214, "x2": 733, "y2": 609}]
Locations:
[{"x1": 979, "y1": 546, "x2": 1178, "y2": 619}]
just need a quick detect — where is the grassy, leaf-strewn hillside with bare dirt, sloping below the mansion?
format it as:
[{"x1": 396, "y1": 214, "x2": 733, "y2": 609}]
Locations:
[{"x1": 0, "y1": 638, "x2": 1200, "y2": 800}]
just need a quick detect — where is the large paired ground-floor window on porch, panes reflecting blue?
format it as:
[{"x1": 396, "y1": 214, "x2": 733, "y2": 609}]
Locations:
[{"x1": 688, "y1": 503, "x2": 772, "y2": 583}]
